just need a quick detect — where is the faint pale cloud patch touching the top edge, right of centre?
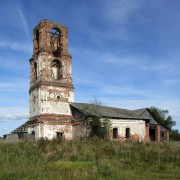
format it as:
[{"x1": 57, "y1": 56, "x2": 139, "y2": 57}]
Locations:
[{"x1": 97, "y1": 0, "x2": 140, "y2": 43}]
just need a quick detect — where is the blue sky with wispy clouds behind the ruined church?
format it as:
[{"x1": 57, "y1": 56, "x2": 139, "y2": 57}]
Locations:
[{"x1": 0, "y1": 0, "x2": 180, "y2": 136}]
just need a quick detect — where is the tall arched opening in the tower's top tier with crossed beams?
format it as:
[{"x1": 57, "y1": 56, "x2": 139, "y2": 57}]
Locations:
[{"x1": 51, "y1": 28, "x2": 61, "y2": 56}]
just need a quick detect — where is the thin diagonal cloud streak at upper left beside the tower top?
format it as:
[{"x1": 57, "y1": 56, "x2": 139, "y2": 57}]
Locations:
[{"x1": 17, "y1": 7, "x2": 31, "y2": 42}]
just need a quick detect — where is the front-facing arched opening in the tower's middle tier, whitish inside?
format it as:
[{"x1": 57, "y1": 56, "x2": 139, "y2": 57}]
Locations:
[{"x1": 51, "y1": 60, "x2": 62, "y2": 80}]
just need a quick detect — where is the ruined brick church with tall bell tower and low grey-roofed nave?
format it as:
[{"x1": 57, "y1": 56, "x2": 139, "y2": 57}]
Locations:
[{"x1": 6, "y1": 20, "x2": 169, "y2": 141}]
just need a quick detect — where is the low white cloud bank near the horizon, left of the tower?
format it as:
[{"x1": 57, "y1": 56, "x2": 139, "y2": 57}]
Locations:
[{"x1": 0, "y1": 113, "x2": 29, "y2": 122}]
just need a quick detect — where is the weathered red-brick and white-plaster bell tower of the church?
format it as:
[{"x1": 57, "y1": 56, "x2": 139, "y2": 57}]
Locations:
[{"x1": 28, "y1": 20, "x2": 74, "y2": 139}]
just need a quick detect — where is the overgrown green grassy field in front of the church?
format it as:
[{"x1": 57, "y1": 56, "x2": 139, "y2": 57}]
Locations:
[{"x1": 0, "y1": 137, "x2": 180, "y2": 180}]
